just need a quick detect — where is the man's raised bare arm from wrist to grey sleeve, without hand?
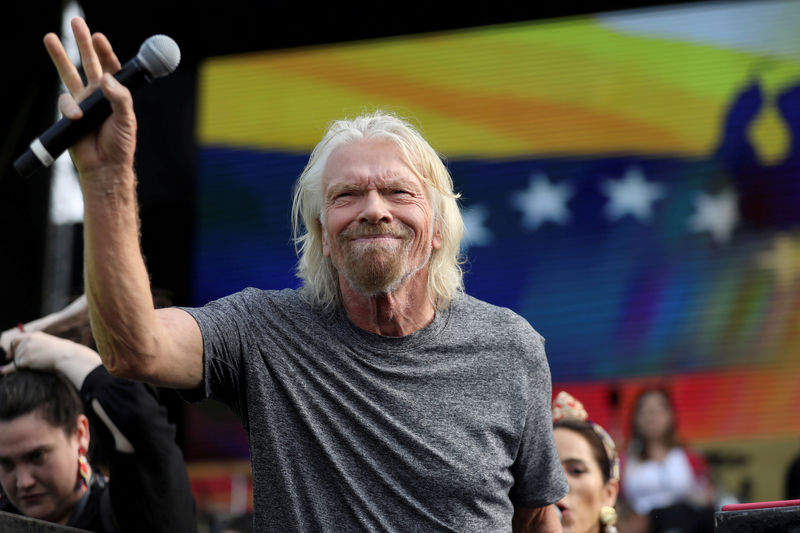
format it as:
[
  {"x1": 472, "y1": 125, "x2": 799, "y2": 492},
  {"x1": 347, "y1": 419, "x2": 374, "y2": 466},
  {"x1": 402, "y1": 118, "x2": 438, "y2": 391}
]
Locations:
[{"x1": 81, "y1": 167, "x2": 203, "y2": 388}]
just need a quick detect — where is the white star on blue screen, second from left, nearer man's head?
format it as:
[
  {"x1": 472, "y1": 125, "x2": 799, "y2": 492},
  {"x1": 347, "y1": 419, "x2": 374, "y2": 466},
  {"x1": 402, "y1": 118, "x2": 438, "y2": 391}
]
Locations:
[{"x1": 511, "y1": 172, "x2": 572, "y2": 230}]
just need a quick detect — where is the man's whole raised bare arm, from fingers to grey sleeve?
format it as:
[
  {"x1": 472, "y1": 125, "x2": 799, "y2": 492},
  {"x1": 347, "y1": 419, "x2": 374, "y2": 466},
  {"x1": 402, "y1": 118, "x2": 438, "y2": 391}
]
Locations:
[{"x1": 44, "y1": 18, "x2": 203, "y2": 388}]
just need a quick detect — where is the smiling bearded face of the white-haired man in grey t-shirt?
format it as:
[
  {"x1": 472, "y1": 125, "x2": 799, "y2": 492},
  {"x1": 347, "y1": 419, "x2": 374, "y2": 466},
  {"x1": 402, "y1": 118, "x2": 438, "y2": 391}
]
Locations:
[{"x1": 322, "y1": 140, "x2": 441, "y2": 296}]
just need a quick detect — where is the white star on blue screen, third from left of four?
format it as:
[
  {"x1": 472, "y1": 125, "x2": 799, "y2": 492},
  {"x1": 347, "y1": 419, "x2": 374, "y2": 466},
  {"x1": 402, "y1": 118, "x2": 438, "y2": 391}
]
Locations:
[{"x1": 602, "y1": 167, "x2": 664, "y2": 221}]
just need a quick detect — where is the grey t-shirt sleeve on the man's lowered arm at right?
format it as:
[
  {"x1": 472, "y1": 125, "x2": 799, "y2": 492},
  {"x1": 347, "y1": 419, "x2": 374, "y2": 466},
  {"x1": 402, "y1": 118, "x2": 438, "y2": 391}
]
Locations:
[{"x1": 509, "y1": 334, "x2": 569, "y2": 508}]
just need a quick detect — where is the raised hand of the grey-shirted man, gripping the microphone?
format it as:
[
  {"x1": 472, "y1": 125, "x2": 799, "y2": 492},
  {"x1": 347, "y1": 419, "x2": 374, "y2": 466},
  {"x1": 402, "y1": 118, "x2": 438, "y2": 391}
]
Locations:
[{"x1": 44, "y1": 18, "x2": 136, "y2": 177}]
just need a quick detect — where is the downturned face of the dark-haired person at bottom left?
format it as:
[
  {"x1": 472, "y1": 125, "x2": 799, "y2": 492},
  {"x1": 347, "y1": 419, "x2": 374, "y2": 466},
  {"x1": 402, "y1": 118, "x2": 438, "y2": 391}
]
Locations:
[{"x1": 0, "y1": 411, "x2": 88, "y2": 524}]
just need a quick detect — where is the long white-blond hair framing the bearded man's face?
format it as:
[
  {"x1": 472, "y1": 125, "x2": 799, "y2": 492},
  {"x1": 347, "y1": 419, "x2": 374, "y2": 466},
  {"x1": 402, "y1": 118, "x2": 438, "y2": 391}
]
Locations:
[{"x1": 292, "y1": 111, "x2": 464, "y2": 309}]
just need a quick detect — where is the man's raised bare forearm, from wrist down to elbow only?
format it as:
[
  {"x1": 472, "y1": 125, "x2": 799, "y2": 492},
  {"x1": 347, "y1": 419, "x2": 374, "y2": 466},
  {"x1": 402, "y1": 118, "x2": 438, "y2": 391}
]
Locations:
[{"x1": 81, "y1": 168, "x2": 158, "y2": 378}]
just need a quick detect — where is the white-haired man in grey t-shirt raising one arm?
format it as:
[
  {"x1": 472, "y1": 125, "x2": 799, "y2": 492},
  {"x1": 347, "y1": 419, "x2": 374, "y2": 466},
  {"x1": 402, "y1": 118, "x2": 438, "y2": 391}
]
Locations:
[{"x1": 45, "y1": 19, "x2": 567, "y2": 532}]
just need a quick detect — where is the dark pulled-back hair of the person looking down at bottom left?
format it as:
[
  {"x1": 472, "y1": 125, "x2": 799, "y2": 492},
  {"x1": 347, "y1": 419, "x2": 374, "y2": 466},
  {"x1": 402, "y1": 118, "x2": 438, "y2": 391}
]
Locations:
[{"x1": 0, "y1": 369, "x2": 83, "y2": 435}]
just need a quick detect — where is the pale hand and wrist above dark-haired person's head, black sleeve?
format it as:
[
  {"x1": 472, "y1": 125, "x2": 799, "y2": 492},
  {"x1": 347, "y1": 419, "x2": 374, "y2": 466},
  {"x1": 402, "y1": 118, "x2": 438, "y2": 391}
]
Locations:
[{"x1": 0, "y1": 331, "x2": 102, "y2": 389}]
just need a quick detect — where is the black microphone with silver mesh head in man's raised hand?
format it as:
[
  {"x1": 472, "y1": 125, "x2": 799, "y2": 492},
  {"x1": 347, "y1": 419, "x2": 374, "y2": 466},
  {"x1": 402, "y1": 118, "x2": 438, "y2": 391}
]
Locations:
[{"x1": 14, "y1": 35, "x2": 181, "y2": 177}]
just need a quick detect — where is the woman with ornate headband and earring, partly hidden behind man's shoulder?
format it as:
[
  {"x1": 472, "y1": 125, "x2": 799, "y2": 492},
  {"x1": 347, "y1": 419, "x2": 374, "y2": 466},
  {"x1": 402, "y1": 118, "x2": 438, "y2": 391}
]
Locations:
[{"x1": 553, "y1": 391, "x2": 619, "y2": 533}]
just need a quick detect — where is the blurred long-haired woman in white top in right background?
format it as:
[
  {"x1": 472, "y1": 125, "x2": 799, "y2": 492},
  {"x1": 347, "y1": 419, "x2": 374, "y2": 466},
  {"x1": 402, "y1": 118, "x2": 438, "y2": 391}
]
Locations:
[{"x1": 621, "y1": 388, "x2": 714, "y2": 533}]
